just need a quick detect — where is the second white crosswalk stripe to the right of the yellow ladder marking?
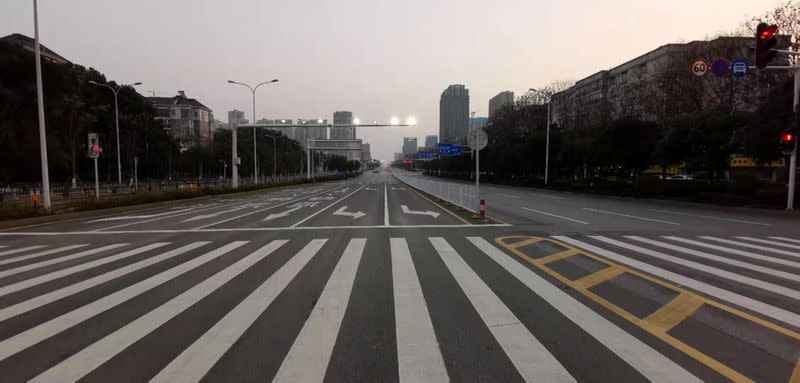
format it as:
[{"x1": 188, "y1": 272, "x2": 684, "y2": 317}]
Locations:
[{"x1": 590, "y1": 235, "x2": 800, "y2": 299}]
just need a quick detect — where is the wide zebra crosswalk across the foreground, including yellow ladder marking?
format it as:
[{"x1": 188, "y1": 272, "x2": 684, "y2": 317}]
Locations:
[{"x1": 0, "y1": 233, "x2": 800, "y2": 382}]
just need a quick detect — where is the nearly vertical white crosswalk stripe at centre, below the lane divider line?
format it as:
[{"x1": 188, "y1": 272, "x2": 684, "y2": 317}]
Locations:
[{"x1": 389, "y1": 238, "x2": 450, "y2": 383}]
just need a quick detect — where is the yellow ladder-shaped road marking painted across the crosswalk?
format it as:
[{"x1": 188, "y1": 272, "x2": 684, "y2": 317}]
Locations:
[{"x1": 495, "y1": 236, "x2": 800, "y2": 383}]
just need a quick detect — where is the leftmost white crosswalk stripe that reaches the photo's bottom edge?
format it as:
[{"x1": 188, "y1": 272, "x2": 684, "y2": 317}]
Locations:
[{"x1": 29, "y1": 240, "x2": 288, "y2": 383}]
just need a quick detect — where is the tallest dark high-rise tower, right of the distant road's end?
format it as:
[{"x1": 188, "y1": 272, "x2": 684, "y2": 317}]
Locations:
[{"x1": 439, "y1": 85, "x2": 469, "y2": 143}]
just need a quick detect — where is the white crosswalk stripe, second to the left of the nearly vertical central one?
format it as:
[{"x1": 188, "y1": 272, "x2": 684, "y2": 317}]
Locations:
[{"x1": 150, "y1": 239, "x2": 327, "y2": 383}]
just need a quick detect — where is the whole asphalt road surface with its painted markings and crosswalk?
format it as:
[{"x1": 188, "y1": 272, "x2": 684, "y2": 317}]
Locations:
[{"x1": 0, "y1": 171, "x2": 800, "y2": 382}]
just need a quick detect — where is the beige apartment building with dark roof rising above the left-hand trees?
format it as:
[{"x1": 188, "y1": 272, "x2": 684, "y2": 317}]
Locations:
[{"x1": 147, "y1": 90, "x2": 214, "y2": 148}]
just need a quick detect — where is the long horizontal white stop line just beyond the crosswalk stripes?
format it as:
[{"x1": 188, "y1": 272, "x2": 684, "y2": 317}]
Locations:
[{"x1": 0, "y1": 223, "x2": 514, "y2": 237}]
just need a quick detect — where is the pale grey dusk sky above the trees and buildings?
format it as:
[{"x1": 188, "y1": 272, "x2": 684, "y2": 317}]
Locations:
[{"x1": 0, "y1": 0, "x2": 779, "y2": 160}]
